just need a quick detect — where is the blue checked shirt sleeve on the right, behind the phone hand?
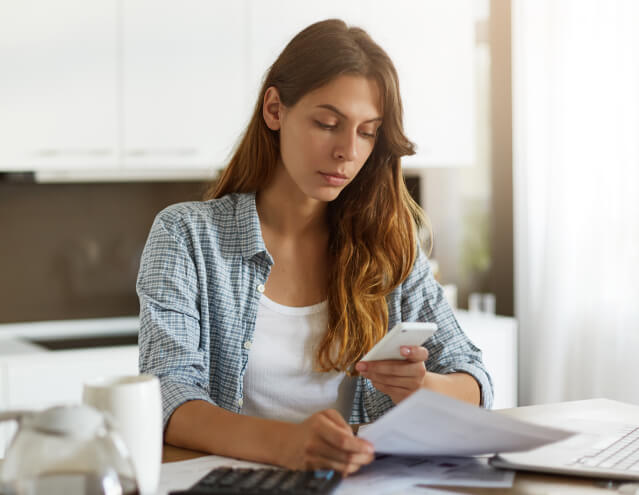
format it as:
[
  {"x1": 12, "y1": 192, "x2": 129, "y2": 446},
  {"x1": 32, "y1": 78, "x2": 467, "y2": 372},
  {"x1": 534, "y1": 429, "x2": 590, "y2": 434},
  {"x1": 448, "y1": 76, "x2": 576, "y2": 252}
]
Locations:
[{"x1": 401, "y1": 251, "x2": 493, "y2": 408}]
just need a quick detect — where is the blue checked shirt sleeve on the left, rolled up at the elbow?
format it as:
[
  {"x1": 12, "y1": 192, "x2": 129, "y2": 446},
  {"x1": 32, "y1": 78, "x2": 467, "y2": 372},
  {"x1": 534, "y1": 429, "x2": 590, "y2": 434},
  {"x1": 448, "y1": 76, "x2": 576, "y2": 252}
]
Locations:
[{"x1": 136, "y1": 214, "x2": 215, "y2": 428}]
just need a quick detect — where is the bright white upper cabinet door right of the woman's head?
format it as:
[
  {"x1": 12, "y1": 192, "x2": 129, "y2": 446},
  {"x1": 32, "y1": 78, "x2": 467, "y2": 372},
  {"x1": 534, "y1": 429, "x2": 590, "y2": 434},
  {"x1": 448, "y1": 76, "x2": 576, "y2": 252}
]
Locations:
[{"x1": 363, "y1": 0, "x2": 476, "y2": 168}]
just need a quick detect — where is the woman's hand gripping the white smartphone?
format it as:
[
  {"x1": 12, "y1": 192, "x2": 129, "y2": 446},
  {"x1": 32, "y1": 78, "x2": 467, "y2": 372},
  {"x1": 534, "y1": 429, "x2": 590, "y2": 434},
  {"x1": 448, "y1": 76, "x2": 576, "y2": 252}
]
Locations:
[{"x1": 355, "y1": 346, "x2": 428, "y2": 404}]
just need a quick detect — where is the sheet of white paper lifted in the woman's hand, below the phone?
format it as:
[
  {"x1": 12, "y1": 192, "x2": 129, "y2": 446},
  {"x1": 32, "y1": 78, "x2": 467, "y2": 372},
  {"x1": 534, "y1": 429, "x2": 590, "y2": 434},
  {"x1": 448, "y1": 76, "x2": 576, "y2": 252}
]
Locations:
[{"x1": 358, "y1": 389, "x2": 574, "y2": 456}]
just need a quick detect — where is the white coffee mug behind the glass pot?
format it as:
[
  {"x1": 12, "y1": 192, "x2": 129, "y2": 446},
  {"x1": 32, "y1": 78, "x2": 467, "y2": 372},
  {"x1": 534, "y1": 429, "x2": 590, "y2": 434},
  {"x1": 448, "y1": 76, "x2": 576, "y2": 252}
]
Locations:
[{"x1": 82, "y1": 375, "x2": 162, "y2": 495}]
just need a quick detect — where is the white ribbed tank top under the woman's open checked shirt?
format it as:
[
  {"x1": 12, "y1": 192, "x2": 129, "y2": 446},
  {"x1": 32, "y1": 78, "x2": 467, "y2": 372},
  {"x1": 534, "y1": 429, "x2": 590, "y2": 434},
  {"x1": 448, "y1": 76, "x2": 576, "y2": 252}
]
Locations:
[{"x1": 242, "y1": 294, "x2": 355, "y2": 423}]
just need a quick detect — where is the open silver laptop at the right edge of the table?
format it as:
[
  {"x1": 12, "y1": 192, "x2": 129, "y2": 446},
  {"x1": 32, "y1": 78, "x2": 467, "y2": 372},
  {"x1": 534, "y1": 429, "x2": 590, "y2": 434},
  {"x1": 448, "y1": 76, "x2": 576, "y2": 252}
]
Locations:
[{"x1": 490, "y1": 419, "x2": 639, "y2": 480}]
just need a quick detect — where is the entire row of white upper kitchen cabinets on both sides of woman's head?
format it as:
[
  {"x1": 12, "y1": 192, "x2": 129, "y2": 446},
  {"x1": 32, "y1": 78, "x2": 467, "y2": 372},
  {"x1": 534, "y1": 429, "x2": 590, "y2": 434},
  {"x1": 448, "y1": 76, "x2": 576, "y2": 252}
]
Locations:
[{"x1": 0, "y1": 0, "x2": 475, "y2": 180}]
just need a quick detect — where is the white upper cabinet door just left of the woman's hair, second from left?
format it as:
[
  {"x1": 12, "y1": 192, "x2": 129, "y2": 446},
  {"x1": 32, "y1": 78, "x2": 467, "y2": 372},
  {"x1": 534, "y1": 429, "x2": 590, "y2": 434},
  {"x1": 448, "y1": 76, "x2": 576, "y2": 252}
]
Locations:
[{"x1": 121, "y1": 0, "x2": 250, "y2": 175}]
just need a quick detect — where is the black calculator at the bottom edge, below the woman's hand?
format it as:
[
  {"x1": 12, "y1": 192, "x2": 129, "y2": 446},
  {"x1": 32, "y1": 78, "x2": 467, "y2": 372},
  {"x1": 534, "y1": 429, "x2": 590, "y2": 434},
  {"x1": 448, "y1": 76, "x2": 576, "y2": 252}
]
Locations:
[{"x1": 169, "y1": 467, "x2": 342, "y2": 495}]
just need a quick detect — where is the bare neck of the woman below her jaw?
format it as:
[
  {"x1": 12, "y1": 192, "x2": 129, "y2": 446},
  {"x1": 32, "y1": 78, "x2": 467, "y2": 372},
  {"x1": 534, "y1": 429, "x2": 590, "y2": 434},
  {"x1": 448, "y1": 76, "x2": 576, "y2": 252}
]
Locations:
[{"x1": 256, "y1": 164, "x2": 327, "y2": 236}]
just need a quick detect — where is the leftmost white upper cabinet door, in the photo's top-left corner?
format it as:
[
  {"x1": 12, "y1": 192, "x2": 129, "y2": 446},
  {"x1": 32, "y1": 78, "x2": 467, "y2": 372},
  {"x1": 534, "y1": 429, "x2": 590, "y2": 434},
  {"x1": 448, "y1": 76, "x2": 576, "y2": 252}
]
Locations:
[{"x1": 0, "y1": 0, "x2": 117, "y2": 171}]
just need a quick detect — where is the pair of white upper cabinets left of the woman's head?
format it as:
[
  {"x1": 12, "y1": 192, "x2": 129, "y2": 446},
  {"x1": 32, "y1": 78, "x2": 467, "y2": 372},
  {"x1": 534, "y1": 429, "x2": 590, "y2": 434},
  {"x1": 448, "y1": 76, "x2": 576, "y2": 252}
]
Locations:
[{"x1": 0, "y1": 0, "x2": 248, "y2": 180}]
